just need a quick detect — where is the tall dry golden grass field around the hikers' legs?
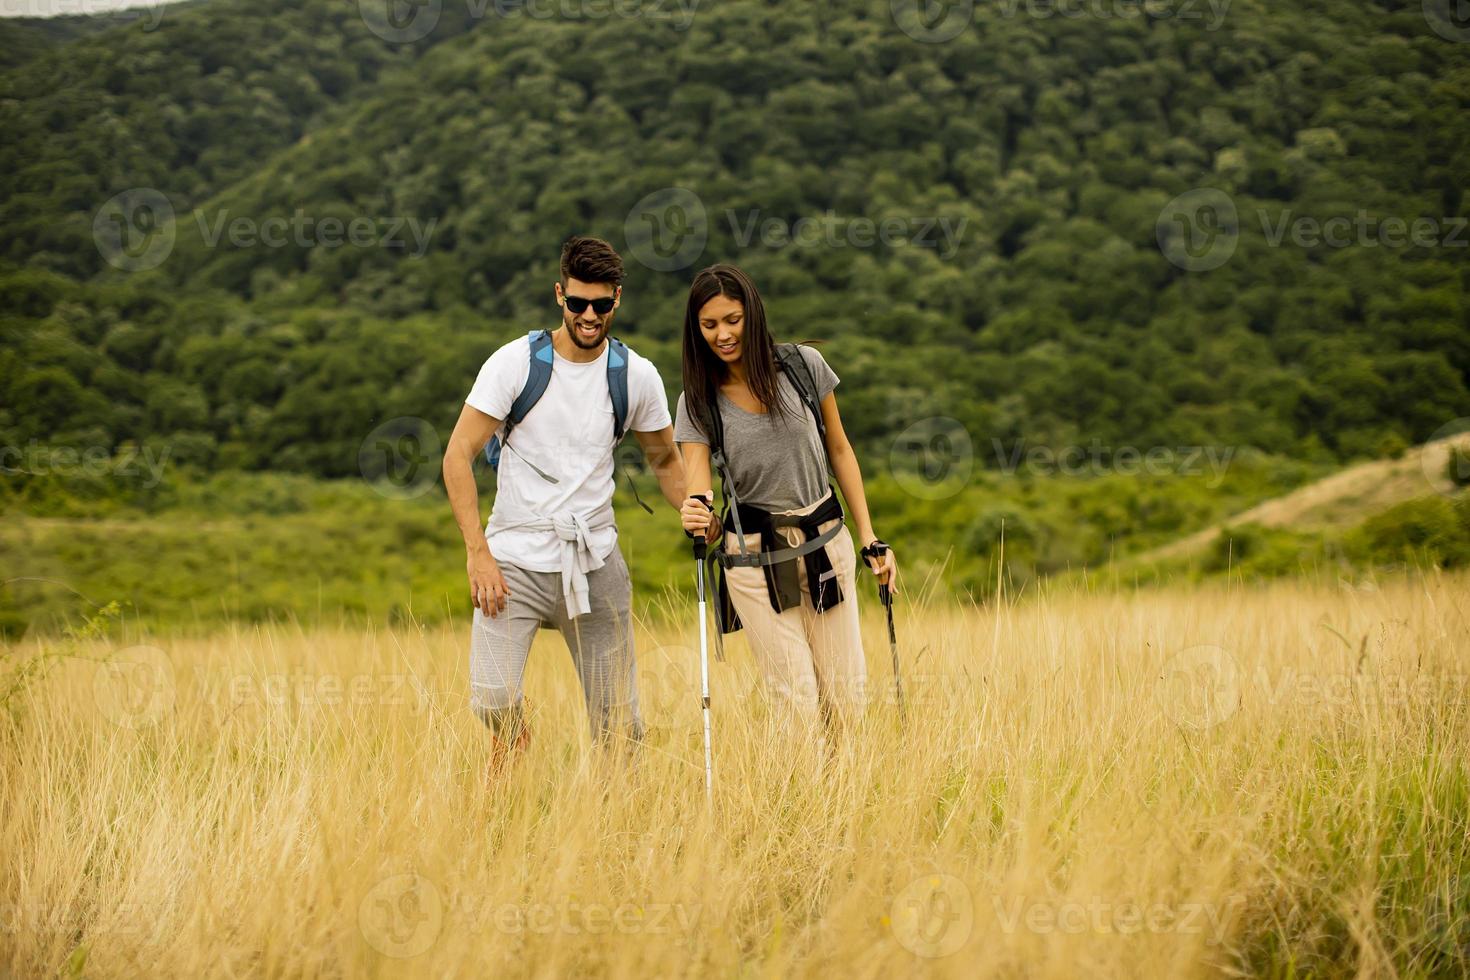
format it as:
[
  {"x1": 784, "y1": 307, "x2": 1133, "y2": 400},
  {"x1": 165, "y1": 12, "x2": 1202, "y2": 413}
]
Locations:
[{"x1": 0, "y1": 576, "x2": 1470, "y2": 979}]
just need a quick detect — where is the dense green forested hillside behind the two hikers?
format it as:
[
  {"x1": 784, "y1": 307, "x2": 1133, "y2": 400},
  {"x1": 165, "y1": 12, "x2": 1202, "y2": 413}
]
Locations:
[{"x1": 0, "y1": 0, "x2": 1470, "y2": 476}]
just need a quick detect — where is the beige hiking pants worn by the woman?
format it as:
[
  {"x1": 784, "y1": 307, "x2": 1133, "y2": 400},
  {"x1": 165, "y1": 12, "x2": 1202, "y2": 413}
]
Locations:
[{"x1": 725, "y1": 501, "x2": 867, "y2": 729}]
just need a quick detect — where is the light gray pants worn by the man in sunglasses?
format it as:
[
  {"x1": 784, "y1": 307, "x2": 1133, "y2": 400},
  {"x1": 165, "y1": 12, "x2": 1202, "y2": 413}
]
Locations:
[{"x1": 469, "y1": 547, "x2": 642, "y2": 739}]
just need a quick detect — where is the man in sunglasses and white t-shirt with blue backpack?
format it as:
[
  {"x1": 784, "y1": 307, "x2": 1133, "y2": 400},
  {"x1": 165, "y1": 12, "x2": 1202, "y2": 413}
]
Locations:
[{"x1": 444, "y1": 237, "x2": 684, "y2": 774}]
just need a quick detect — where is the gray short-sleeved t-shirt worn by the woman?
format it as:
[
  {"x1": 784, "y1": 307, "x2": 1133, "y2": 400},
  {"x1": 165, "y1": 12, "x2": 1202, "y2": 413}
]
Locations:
[{"x1": 673, "y1": 347, "x2": 838, "y2": 511}]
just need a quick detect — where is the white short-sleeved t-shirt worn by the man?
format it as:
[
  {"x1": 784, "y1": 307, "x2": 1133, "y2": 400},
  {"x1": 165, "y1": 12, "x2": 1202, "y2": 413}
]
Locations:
[{"x1": 465, "y1": 335, "x2": 672, "y2": 572}]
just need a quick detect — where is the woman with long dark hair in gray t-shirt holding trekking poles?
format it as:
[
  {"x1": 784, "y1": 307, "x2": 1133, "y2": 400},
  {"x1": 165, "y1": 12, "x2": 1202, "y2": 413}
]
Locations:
[{"x1": 673, "y1": 264, "x2": 898, "y2": 740}]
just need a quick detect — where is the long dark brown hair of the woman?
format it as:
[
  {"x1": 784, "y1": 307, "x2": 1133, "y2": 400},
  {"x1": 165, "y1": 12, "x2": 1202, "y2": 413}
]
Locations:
[{"x1": 684, "y1": 263, "x2": 785, "y2": 436}]
